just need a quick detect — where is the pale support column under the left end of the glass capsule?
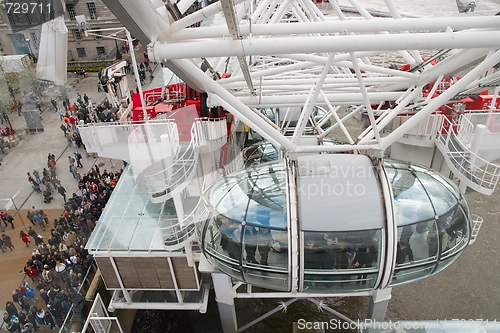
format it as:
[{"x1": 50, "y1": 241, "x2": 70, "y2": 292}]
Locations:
[{"x1": 212, "y1": 273, "x2": 238, "y2": 333}]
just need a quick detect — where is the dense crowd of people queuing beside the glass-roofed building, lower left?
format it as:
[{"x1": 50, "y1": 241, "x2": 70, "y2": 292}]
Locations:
[{"x1": 0, "y1": 166, "x2": 121, "y2": 332}]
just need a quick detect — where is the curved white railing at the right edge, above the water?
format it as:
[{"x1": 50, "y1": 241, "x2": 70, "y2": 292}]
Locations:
[{"x1": 436, "y1": 117, "x2": 500, "y2": 194}]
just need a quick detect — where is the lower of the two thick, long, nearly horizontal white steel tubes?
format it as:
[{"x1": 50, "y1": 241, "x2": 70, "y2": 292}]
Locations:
[{"x1": 152, "y1": 31, "x2": 500, "y2": 61}]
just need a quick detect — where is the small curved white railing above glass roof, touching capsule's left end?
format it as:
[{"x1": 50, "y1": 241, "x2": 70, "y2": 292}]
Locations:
[{"x1": 159, "y1": 199, "x2": 210, "y2": 250}]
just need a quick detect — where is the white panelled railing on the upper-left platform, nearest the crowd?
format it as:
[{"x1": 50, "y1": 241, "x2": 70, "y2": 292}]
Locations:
[{"x1": 78, "y1": 119, "x2": 179, "y2": 151}]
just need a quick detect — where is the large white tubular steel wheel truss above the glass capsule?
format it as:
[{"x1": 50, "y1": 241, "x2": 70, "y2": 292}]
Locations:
[{"x1": 115, "y1": 0, "x2": 500, "y2": 153}]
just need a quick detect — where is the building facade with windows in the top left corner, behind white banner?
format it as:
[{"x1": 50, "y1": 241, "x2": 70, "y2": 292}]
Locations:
[{"x1": 0, "y1": 0, "x2": 122, "y2": 61}]
